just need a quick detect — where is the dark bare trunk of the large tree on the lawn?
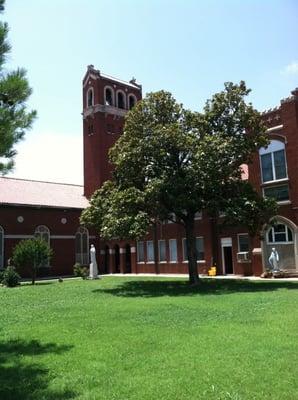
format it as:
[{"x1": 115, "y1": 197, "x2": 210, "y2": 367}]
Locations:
[{"x1": 185, "y1": 216, "x2": 199, "y2": 285}]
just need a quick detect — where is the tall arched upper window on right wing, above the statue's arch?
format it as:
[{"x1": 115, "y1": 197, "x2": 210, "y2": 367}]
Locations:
[{"x1": 259, "y1": 140, "x2": 289, "y2": 201}]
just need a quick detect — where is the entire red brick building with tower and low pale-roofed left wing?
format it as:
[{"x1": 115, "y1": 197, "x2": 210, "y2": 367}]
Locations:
[{"x1": 0, "y1": 65, "x2": 298, "y2": 275}]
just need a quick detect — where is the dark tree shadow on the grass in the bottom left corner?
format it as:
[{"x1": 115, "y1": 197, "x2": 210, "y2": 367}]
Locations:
[{"x1": 0, "y1": 340, "x2": 76, "y2": 400}]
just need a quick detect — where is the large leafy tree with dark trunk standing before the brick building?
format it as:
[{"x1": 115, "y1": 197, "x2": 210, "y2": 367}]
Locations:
[{"x1": 82, "y1": 82, "x2": 275, "y2": 284}]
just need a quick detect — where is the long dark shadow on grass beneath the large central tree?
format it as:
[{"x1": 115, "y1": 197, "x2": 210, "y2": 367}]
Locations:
[{"x1": 93, "y1": 279, "x2": 298, "y2": 297}]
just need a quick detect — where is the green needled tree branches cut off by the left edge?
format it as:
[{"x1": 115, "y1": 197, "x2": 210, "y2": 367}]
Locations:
[{"x1": 0, "y1": 0, "x2": 36, "y2": 173}]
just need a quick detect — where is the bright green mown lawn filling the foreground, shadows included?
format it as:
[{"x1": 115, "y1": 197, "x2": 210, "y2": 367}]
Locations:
[{"x1": 0, "y1": 277, "x2": 298, "y2": 400}]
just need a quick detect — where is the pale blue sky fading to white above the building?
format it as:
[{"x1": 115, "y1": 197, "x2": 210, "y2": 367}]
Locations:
[{"x1": 2, "y1": 0, "x2": 298, "y2": 183}]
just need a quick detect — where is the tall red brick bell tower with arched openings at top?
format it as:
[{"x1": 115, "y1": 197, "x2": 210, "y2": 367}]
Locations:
[{"x1": 82, "y1": 65, "x2": 142, "y2": 198}]
